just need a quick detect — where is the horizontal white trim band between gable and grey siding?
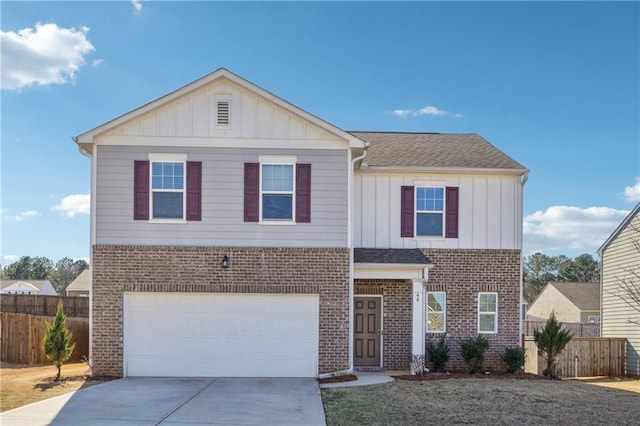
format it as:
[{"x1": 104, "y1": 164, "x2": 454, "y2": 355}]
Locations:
[{"x1": 96, "y1": 136, "x2": 347, "y2": 150}]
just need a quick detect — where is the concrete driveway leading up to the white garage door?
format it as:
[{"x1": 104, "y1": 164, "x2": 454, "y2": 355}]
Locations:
[{"x1": 0, "y1": 378, "x2": 326, "y2": 426}]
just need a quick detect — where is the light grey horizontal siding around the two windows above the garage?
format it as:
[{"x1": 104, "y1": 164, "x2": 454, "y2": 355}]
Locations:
[{"x1": 95, "y1": 145, "x2": 348, "y2": 247}]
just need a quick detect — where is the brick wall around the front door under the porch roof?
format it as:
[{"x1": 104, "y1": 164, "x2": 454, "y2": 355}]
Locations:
[{"x1": 354, "y1": 280, "x2": 412, "y2": 370}]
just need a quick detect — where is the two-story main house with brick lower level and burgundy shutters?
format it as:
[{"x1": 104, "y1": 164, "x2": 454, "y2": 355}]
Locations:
[{"x1": 74, "y1": 68, "x2": 528, "y2": 377}]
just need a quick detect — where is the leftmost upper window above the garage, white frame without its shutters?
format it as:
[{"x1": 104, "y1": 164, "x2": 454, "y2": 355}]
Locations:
[{"x1": 149, "y1": 154, "x2": 186, "y2": 221}]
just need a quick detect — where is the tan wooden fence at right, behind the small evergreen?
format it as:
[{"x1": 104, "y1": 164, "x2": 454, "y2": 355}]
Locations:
[{"x1": 524, "y1": 337, "x2": 627, "y2": 377}]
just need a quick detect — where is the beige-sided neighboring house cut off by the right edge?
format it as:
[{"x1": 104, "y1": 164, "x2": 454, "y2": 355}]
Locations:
[{"x1": 598, "y1": 203, "x2": 640, "y2": 375}]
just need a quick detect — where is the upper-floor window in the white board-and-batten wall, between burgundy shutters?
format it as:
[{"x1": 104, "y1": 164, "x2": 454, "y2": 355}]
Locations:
[{"x1": 415, "y1": 186, "x2": 445, "y2": 237}]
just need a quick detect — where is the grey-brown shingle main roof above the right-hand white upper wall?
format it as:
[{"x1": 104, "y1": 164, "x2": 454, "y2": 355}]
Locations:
[{"x1": 350, "y1": 132, "x2": 526, "y2": 172}]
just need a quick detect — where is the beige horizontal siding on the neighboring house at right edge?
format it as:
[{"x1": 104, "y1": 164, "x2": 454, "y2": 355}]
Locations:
[{"x1": 600, "y1": 214, "x2": 640, "y2": 375}]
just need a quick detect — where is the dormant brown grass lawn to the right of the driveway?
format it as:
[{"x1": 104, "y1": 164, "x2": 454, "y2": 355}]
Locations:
[{"x1": 322, "y1": 378, "x2": 640, "y2": 426}]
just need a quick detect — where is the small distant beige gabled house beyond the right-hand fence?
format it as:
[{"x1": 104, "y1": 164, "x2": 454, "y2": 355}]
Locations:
[{"x1": 527, "y1": 281, "x2": 600, "y2": 324}]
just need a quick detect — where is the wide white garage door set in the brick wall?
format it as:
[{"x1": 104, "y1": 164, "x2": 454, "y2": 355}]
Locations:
[{"x1": 124, "y1": 293, "x2": 318, "y2": 377}]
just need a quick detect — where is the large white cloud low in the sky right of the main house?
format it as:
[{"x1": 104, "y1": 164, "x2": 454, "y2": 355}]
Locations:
[{"x1": 523, "y1": 206, "x2": 629, "y2": 257}]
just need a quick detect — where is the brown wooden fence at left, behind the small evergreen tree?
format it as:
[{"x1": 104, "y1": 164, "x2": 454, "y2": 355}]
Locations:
[{"x1": 0, "y1": 312, "x2": 89, "y2": 365}]
